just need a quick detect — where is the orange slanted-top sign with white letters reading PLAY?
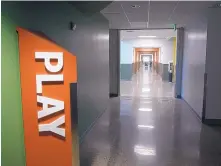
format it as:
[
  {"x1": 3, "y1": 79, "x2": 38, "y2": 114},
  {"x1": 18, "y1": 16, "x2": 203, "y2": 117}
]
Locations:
[{"x1": 18, "y1": 28, "x2": 78, "y2": 166}]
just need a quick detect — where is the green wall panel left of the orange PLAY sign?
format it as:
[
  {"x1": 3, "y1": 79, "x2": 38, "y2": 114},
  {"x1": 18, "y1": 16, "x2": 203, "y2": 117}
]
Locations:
[{"x1": 1, "y1": 15, "x2": 25, "y2": 166}]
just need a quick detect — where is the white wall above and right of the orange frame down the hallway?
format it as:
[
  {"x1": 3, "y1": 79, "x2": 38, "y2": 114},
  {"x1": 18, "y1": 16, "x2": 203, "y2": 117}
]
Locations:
[{"x1": 124, "y1": 39, "x2": 173, "y2": 64}]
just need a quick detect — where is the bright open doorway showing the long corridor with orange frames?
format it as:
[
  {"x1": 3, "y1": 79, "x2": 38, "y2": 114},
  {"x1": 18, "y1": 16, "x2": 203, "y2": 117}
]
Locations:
[{"x1": 120, "y1": 30, "x2": 176, "y2": 97}]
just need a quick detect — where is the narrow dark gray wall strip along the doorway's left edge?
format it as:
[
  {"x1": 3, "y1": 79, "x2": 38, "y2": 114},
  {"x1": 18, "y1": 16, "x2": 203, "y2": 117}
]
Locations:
[{"x1": 109, "y1": 29, "x2": 120, "y2": 95}]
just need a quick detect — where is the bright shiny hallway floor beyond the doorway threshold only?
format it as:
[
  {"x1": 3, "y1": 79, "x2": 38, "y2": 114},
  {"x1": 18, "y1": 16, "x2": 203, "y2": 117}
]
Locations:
[{"x1": 120, "y1": 67, "x2": 174, "y2": 98}]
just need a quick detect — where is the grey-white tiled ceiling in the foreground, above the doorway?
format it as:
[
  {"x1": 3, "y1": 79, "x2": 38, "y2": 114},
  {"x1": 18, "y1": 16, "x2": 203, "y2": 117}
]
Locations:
[{"x1": 101, "y1": 0, "x2": 218, "y2": 29}]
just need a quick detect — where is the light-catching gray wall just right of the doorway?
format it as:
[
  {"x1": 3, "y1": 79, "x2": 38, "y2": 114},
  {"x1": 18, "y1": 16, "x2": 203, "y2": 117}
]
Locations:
[{"x1": 182, "y1": 9, "x2": 207, "y2": 117}]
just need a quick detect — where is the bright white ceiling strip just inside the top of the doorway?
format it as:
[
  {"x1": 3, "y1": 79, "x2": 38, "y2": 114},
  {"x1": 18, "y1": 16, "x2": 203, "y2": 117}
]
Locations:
[{"x1": 120, "y1": 29, "x2": 176, "y2": 40}]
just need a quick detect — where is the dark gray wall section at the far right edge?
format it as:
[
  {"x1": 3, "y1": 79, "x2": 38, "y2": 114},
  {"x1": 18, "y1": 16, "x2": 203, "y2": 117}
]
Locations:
[{"x1": 205, "y1": 8, "x2": 221, "y2": 119}]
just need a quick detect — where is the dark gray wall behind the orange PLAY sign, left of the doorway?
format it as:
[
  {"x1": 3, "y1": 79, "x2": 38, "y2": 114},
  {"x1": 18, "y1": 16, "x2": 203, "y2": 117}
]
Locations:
[{"x1": 2, "y1": 2, "x2": 109, "y2": 139}]
